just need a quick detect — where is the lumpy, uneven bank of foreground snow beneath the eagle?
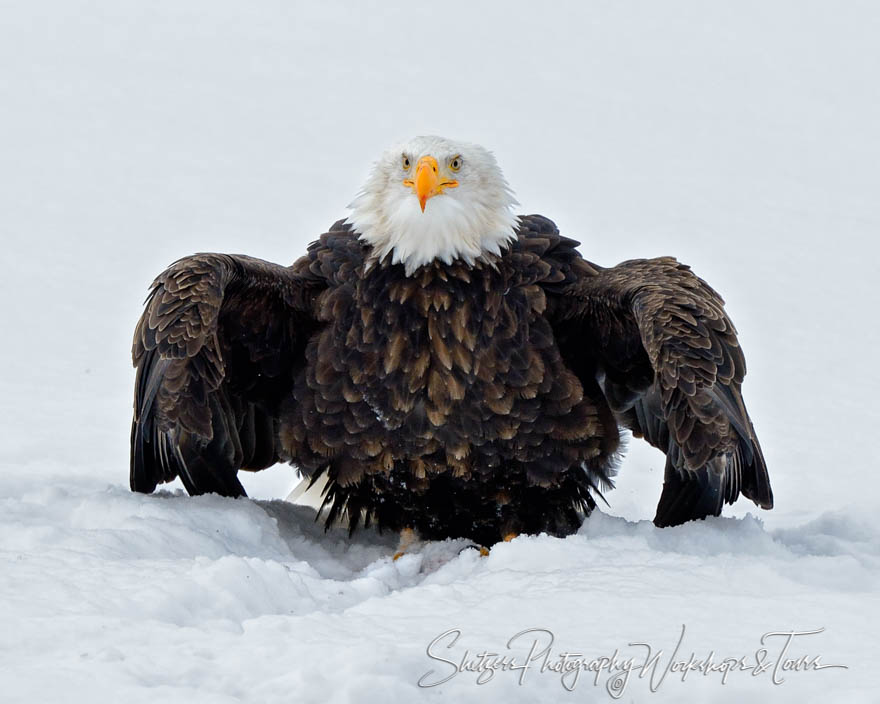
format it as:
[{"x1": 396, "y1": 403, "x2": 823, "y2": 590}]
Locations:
[{"x1": 0, "y1": 477, "x2": 880, "y2": 701}]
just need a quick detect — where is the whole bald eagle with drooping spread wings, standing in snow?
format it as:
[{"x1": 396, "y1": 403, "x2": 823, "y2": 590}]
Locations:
[{"x1": 130, "y1": 137, "x2": 773, "y2": 545}]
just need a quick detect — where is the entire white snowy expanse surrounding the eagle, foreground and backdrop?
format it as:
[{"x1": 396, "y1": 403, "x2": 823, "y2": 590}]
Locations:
[{"x1": 0, "y1": 0, "x2": 880, "y2": 702}]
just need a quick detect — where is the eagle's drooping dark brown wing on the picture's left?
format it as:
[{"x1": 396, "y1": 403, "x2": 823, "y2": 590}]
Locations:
[{"x1": 130, "y1": 254, "x2": 320, "y2": 496}]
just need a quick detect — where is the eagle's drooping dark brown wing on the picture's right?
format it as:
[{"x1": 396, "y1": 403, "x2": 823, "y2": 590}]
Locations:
[{"x1": 536, "y1": 223, "x2": 773, "y2": 526}]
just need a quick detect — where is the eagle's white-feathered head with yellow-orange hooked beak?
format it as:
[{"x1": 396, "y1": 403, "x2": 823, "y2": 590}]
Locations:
[{"x1": 348, "y1": 137, "x2": 517, "y2": 276}]
